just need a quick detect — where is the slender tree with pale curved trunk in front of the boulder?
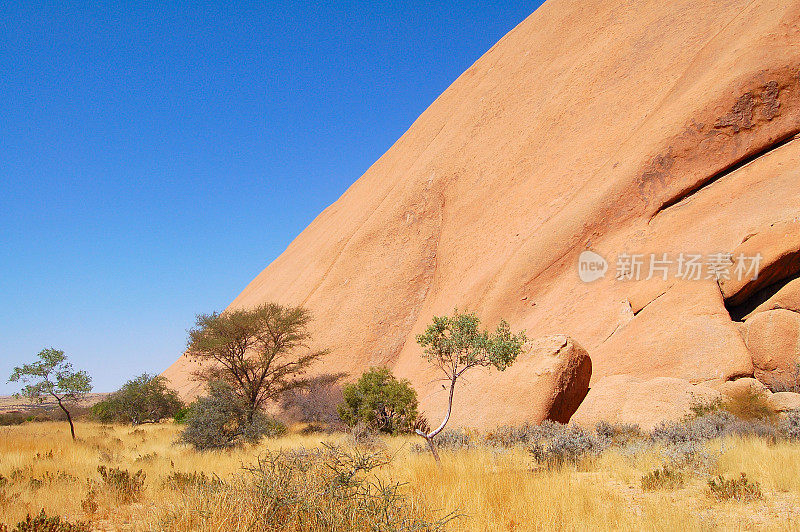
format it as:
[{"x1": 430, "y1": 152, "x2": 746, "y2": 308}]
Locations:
[{"x1": 416, "y1": 309, "x2": 527, "y2": 462}]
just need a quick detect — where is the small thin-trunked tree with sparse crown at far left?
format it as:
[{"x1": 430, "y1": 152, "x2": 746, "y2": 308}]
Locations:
[{"x1": 8, "y1": 347, "x2": 92, "y2": 440}]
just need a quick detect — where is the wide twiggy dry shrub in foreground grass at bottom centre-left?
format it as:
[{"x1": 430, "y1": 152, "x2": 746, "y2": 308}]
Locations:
[{"x1": 156, "y1": 446, "x2": 454, "y2": 531}]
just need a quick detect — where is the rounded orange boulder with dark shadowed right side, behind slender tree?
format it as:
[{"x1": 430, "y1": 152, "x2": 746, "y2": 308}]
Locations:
[{"x1": 420, "y1": 336, "x2": 592, "y2": 429}]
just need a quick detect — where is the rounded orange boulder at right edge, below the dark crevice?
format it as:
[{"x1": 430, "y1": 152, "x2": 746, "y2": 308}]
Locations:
[{"x1": 742, "y1": 309, "x2": 800, "y2": 388}]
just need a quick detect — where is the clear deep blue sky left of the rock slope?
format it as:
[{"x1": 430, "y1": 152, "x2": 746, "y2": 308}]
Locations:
[{"x1": 0, "y1": 1, "x2": 540, "y2": 394}]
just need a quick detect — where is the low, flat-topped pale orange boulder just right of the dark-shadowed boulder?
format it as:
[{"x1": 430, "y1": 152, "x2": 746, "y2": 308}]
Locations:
[{"x1": 572, "y1": 375, "x2": 722, "y2": 430}]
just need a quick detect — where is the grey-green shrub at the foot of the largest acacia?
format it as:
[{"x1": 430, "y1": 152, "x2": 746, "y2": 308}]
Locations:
[{"x1": 180, "y1": 381, "x2": 286, "y2": 451}]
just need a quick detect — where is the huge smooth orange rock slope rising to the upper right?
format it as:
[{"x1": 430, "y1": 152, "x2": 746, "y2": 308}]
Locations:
[{"x1": 165, "y1": 0, "x2": 800, "y2": 424}]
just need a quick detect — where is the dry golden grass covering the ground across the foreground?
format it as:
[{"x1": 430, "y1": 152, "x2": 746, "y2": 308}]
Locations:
[{"x1": 0, "y1": 423, "x2": 800, "y2": 531}]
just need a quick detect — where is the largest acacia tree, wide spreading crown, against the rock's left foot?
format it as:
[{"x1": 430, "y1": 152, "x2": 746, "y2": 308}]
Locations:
[{"x1": 188, "y1": 303, "x2": 327, "y2": 422}]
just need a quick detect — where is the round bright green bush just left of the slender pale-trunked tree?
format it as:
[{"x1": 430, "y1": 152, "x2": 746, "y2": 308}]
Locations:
[{"x1": 337, "y1": 368, "x2": 418, "y2": 434}]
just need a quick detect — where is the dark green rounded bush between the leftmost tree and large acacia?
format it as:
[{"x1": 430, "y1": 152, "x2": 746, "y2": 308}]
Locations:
[{"x1": 92, "y1": 373, "x2": 183, "y2": 425}]
